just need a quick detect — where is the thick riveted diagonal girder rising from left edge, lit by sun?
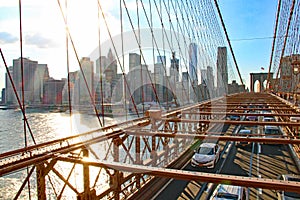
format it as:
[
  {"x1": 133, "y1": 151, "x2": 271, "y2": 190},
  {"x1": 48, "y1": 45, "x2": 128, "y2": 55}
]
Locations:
[{"x1": 0, "y1": 118, "x2": 150, "y2": 177}]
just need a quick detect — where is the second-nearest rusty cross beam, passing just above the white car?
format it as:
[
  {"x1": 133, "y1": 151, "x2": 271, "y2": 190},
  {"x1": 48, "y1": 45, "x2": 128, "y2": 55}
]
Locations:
[{"x1": 125, "y1": 131, "x2": 300, "y2": 145}]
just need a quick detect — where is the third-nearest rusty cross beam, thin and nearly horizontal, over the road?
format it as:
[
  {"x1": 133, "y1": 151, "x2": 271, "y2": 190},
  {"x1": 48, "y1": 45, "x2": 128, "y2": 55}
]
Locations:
[{"x1": 162, "y1": 118, "x2": 300, "y2": 126}]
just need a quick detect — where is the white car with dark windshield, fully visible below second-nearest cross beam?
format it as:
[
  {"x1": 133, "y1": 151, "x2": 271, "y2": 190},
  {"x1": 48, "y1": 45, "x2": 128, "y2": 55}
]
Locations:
[{"x1": 191, "y1": 143, "x2": 220, "y2": 168}]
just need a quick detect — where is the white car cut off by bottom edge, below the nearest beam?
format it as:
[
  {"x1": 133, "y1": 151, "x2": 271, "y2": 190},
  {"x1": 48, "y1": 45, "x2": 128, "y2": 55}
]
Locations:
[{"x1": 210, "y1": 184, "x2": 246, "y2": 200}]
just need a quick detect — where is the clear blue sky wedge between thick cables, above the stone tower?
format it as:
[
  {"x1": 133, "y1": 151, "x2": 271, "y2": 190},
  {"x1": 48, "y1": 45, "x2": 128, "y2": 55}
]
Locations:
[{"x1": 218, "y1": 0, "x2": 277, "y2": 87}]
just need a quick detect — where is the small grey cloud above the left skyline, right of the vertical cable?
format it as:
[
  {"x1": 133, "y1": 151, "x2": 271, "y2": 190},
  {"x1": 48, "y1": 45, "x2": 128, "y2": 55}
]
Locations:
[{"x1": 25, "y1": 33, "x2": 57, "y2": 48}]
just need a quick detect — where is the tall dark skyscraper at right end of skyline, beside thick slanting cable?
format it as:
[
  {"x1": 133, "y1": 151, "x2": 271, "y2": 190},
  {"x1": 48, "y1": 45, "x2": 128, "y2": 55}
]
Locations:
[{"x1": 217, "y1": 47, "x2": 228, "y2": 95}]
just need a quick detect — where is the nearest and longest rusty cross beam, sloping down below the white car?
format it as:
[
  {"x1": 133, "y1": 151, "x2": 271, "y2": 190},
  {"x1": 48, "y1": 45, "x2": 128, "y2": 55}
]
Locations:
[{"x1": 59, "y1": 157, "x2": 300, "y2": 192}]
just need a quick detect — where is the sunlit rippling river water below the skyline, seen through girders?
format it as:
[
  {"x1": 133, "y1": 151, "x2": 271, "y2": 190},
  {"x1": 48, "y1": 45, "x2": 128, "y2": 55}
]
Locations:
[{"x1": 0, "y1": 109, "x2": 127, "y2": 199}]
